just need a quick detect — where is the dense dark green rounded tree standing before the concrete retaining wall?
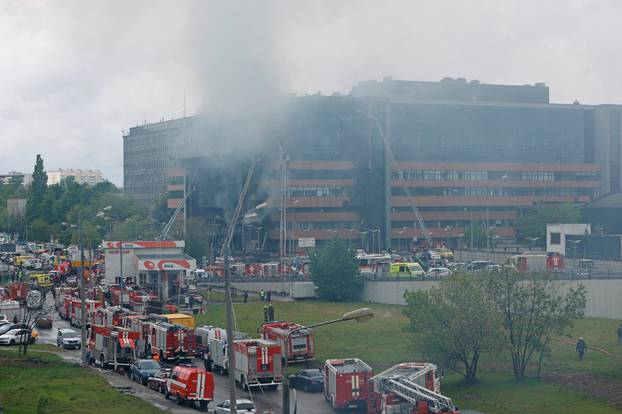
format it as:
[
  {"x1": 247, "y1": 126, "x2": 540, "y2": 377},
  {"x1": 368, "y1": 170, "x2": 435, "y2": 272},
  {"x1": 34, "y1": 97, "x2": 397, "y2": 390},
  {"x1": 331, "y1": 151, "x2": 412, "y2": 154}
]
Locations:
[{"x1": 311, "y1": 238, "x2": 363, "y2": 302}]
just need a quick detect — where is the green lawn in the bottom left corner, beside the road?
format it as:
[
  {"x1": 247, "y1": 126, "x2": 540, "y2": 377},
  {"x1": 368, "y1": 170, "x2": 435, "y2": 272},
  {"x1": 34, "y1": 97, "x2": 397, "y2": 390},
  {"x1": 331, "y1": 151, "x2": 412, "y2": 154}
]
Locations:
[{"x1": 0, "y1": 346, "x2": 162, "y2": 414}]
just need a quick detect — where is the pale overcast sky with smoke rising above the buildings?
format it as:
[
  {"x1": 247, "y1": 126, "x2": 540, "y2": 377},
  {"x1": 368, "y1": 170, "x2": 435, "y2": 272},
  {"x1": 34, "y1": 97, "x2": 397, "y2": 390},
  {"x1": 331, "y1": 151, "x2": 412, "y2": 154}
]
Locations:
[{"x1": 0, "y1": 0, "x2": 622, "y2": 184}]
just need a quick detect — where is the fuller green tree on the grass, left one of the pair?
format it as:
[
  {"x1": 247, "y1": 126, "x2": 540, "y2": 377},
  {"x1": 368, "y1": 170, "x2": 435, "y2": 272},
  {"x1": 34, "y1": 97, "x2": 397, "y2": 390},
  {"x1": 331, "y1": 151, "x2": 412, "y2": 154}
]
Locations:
[{"x1": 403, "y1": 274, "x2": 502, "y2": 381}]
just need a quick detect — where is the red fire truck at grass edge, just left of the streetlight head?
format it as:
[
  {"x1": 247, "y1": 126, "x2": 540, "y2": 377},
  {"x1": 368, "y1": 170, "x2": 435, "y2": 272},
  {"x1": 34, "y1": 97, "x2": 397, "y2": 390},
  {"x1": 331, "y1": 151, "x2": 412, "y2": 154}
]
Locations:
[{"x1": 259, "y1": 322, "x2": 315, "y2": 362}]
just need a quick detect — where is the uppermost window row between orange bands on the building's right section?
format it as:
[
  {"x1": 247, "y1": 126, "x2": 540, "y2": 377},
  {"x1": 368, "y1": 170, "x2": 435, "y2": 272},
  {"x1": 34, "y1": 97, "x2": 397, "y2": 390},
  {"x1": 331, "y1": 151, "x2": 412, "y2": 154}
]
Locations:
[{"x1": 391, "y1": 170, "x2": 598, "y2": 181}]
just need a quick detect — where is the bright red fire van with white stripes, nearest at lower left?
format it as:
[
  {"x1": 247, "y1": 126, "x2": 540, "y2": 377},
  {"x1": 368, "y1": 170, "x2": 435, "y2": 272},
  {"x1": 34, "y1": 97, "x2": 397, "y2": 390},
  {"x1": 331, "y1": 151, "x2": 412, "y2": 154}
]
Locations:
[{"x1": 164, "y1": 365, "x2": 214, "y2": 410}]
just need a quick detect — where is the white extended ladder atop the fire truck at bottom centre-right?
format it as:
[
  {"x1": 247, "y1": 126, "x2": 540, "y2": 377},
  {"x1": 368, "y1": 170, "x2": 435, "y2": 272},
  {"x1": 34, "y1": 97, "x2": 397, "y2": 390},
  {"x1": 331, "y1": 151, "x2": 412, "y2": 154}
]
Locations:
[{"x1": 370, "y1": 363, "x2": 456, "y2": 413}]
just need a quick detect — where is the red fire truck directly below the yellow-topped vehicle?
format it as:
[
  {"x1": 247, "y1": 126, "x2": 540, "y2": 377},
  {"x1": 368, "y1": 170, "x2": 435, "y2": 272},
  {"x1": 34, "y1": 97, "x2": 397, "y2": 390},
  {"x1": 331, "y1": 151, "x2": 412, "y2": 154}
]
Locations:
[{"x1": 147, "y1": 322, "x2": 194, "y2": 361}]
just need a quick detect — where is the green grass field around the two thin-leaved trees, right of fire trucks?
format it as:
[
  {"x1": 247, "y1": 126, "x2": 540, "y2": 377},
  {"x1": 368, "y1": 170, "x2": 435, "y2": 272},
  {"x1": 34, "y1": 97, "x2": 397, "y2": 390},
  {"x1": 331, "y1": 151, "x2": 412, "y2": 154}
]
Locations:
[{"x1": 198, "y1": 301, "x2": 622, "y2": 414}]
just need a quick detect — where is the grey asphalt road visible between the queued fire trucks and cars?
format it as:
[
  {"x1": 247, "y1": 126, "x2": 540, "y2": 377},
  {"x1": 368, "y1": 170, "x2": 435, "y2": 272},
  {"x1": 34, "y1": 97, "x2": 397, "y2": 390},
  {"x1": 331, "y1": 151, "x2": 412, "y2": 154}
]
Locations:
[{"x1": 38, "y1": 297, "x2": 333, "y2": 414}]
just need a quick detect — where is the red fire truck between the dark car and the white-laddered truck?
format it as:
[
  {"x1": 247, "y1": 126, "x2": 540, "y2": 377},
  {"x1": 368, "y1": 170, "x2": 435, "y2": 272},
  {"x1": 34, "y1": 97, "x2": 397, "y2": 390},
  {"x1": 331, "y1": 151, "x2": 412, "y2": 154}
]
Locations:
[{"x1": 322, "y1": 358, "x2": 373, "y2": 409}]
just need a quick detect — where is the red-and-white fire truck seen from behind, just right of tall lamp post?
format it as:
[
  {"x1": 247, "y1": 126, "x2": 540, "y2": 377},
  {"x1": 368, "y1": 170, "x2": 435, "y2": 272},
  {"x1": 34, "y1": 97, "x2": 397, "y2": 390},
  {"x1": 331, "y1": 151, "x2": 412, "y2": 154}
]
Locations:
[{"x1": 233, "y1": 339, "x2": 283, "y2": 390}]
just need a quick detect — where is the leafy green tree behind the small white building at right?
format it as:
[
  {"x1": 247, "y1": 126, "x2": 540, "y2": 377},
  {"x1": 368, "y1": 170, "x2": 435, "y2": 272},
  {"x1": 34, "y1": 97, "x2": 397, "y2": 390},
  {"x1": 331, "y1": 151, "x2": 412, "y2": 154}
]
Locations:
[{"x1": 516, "y1": 203, "x2": 581, "y2": 243}]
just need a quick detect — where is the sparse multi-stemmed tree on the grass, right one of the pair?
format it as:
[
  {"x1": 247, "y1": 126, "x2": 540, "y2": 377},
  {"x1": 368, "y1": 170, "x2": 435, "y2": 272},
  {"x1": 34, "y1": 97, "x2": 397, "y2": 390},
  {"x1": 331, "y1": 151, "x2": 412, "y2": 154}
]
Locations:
[{"x1": 485, "y1": 272, "x2": 586, "y2": 379}]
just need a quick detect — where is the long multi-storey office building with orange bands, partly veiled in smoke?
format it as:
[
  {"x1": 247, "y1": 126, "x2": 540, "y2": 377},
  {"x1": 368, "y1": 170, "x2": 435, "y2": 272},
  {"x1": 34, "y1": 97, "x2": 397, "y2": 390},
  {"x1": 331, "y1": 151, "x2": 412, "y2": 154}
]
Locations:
[{"x1": 124, "y1": 79, "x2": 622, "y2": 249}]
